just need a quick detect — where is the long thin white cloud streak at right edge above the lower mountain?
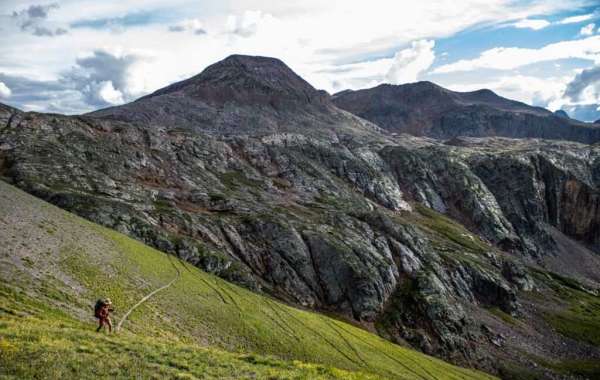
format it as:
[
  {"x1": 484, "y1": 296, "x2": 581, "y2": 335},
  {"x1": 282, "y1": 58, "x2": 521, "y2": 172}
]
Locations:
[{"x1": 434, "y1": 36, "x2": 600, "y2": 73}]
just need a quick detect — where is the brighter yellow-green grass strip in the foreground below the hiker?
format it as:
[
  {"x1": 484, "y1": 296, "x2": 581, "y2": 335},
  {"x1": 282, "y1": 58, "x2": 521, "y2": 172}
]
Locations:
[{"x1": 0, "y1": 289, "x2": 378, "y2": 379}]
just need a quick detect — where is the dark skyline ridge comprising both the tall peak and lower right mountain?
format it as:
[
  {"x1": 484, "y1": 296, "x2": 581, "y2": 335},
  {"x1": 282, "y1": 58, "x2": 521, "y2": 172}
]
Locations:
[{"x1": 3, "y1": 54, "x2": 600, "y2": 143}]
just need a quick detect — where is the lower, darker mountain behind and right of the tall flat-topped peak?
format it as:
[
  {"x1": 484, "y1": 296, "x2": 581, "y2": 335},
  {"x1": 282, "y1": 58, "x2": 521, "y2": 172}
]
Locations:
[{"x1": 332, "y1": 82, "x2": 600, "y2": 144}]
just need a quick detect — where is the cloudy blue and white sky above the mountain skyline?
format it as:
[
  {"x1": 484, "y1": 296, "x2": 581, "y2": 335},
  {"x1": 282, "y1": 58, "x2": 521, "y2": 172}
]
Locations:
[{"x1": 0, "y1": 0, "x2": 600, "y2": 121}]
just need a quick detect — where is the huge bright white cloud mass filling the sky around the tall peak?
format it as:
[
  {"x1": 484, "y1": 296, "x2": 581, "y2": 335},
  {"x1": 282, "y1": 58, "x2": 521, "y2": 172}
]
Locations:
[{"x1": 0, "y1": 0, "x2": 592, "y2": 110}]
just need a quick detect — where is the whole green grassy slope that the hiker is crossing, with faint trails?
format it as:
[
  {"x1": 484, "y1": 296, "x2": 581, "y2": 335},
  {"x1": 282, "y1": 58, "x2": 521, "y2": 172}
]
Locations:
[{"x1": 0, "y1": 182, "x2": 496, "y2": 379}]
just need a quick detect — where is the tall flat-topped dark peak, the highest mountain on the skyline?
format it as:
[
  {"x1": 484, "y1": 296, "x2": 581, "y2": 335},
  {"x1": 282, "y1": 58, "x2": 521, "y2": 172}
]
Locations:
[{"x1": 89, "y1": 55, "x2": 377, "y2": 137}]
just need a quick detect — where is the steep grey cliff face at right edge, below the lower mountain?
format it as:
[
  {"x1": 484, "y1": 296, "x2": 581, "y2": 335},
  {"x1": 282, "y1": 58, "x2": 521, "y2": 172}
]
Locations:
[{"x1": 382, "y1": 139, "x2": 600, "y2": 257}]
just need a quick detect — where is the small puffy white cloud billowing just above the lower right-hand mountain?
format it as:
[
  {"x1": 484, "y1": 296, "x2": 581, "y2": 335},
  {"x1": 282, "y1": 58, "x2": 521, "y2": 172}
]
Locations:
[{"x1": 386, "y1": 40, "x2": 435, "y2": 84}]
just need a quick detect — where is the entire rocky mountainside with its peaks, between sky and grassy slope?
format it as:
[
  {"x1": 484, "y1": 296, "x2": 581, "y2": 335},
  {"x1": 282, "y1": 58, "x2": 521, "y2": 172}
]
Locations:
[{"x1": 0, "y1": 56, "x2": 600, "y2": 378}]
